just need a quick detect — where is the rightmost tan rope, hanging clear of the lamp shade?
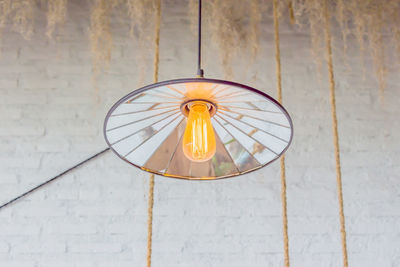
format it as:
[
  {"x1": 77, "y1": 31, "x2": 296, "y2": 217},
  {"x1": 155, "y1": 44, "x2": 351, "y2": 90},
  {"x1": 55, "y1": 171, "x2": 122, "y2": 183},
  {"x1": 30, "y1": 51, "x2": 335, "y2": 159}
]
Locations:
[{"x1": 323, "y1": 0, "x2": 349, "y2": 267}]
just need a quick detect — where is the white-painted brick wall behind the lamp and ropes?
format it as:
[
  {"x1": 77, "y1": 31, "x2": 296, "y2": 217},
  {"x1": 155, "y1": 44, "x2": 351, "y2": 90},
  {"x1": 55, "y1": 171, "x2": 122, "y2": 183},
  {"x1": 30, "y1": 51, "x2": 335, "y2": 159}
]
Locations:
[{"x1": 0, "y1": 1, "x2": 400, "y2": 267}]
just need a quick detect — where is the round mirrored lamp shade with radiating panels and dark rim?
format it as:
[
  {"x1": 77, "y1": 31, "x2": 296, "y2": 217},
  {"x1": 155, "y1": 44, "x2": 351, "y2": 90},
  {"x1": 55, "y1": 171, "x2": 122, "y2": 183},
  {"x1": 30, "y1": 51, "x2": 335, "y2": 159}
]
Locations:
[{"x1": 104, "y1": 78, "x2": 293, "y2": 180}]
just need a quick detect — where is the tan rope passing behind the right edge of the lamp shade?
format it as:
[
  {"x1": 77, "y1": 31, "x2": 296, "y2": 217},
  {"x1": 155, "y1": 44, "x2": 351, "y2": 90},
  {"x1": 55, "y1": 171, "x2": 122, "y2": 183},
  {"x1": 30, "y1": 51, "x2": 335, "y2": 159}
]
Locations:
[{"x1": 273, "y1": 0, "x2": 290, "y2": 267}]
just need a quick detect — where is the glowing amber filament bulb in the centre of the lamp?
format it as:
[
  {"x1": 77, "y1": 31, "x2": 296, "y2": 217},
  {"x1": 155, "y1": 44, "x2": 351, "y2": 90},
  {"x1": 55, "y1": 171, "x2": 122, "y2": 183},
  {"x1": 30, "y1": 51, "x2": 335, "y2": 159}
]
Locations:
[{"x1": 183, "y1": 101, "x2": 216, "y2": 162}]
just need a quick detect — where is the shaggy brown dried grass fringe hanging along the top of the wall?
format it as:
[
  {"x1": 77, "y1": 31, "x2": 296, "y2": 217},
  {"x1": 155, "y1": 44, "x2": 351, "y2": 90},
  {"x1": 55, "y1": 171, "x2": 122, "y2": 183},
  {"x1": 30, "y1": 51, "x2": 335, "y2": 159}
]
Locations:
[{"x1": 0, "y1": 0, "x2": 400, "y2": 97}]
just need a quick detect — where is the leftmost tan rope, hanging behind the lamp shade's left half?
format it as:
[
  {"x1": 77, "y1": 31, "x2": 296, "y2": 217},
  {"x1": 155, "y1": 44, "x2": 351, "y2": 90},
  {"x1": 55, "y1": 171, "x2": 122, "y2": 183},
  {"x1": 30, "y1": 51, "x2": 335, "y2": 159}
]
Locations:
[{"x1": 147, "y1": 0, "x2": 161, "y2": 267}]
